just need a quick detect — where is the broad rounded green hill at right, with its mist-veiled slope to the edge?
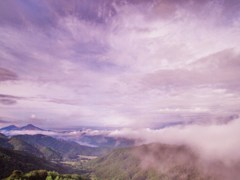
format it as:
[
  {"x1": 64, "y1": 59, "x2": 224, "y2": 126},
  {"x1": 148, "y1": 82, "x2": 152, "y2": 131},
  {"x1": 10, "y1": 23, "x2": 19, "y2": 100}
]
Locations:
[{"x1": 88, "y1": 143, "x2": 240, "y2": 180}]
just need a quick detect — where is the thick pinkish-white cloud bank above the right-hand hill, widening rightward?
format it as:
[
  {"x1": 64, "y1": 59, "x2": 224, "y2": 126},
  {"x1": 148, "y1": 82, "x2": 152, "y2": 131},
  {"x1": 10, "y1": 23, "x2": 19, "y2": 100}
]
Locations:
[{"x1": 110, "y1": 119, "x2": 240, "y2": 163}]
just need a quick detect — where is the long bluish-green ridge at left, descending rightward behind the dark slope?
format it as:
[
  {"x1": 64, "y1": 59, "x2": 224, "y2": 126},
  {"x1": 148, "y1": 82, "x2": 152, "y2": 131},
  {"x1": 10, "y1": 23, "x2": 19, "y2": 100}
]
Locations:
[{"x1": 0, "y1": 134, "x2": 105, "y2": 161}]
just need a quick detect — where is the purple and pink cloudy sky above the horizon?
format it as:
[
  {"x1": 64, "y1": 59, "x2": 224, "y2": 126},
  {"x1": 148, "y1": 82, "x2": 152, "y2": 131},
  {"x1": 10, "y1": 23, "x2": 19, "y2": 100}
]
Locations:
[{"x1": 0, "y1": 0, "x2": 240, "y2": 128}]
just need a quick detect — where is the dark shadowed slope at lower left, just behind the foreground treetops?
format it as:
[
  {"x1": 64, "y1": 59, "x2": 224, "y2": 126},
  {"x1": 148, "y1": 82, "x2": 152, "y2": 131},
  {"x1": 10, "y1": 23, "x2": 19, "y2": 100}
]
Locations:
[{"x1": 0, "y1": 147, "x2": 64, "y2": 179}]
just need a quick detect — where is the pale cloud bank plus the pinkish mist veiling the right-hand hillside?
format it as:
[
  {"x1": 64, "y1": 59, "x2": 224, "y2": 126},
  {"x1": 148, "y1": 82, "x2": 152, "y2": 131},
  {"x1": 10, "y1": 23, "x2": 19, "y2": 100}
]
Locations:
[{"x1": 107, "y1": 119, "x2": 240, "y2": 180}]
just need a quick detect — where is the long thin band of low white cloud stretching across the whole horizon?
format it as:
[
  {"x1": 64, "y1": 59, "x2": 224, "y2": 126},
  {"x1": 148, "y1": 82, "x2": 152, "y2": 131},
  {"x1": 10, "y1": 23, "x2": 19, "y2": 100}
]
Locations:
[{"x1": 5, "y1": 119, "x2": 240, "y2": 163}]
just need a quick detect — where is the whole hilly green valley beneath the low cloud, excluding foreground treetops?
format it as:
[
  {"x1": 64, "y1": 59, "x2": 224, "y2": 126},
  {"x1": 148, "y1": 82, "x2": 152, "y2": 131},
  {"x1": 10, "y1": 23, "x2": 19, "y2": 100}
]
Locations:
[{"x1": 0, "y1": 124, "x2": 240, "y2": 180}]
